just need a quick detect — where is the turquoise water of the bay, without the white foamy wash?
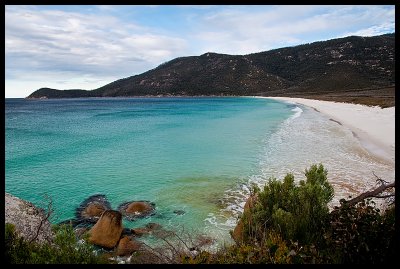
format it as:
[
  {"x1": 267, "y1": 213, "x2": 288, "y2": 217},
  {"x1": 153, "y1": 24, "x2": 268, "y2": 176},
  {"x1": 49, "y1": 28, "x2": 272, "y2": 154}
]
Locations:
[{"x1": 5, "y1": 98, "x2": 301, "y2": 243}]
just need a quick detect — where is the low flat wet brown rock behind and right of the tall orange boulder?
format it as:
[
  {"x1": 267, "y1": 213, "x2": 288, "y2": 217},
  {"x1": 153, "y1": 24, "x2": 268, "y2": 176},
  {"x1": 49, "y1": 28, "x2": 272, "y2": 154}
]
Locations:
[{"x1": 118, "y1": 201, "x2": 155, "y2": 220}]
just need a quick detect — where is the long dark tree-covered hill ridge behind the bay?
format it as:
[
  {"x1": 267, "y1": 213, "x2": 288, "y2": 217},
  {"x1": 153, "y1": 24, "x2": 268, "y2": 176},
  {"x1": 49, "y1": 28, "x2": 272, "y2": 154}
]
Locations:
[{"x1": 28, "y1": 33, "x2": 395, "y2": 105}]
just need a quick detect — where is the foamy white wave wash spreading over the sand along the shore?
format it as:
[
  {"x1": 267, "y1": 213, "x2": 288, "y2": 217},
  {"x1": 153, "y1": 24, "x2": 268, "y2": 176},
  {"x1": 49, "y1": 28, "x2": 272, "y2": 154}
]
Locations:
[{"x1": 206, "y1": 103, "x2": 394, "y2": 238}]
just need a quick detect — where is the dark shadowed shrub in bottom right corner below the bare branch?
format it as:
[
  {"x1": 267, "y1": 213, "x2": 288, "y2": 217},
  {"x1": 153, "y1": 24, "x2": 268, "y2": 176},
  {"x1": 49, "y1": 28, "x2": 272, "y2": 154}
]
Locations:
[{"x1": 326, "y1": 200, "x2": 396, "y2": 263}]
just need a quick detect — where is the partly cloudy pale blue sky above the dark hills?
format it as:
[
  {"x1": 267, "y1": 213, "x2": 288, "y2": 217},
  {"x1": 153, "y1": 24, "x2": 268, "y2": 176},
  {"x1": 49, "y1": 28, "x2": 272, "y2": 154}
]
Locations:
[{"x1": 5, "y1": 5, "x2": 395, "y2": 98}]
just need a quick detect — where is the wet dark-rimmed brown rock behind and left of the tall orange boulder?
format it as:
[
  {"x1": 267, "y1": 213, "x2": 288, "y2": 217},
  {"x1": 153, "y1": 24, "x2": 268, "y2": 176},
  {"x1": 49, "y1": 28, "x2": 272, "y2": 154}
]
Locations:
[{"x1": 75, "y1": 194, "x2": 111, "y2": 224}]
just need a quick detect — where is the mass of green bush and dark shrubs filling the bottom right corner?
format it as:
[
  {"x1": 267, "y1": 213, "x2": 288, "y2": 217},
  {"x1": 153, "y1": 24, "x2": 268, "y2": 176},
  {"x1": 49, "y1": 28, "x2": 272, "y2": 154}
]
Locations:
[{"x1": 185, "y1": 164, "x2": 396, "y2": 264}]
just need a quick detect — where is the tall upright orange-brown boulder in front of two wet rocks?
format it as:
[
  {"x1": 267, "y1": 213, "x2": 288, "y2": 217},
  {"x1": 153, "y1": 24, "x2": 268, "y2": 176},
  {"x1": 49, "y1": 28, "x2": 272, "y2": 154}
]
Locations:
[{"x1": 89, "y1": 210, "x2": 122, "y2": 248}]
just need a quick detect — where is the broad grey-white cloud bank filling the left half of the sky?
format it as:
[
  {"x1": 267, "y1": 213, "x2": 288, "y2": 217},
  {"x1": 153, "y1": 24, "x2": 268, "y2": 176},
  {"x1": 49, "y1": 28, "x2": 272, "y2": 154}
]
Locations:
[{"x1": 5, "y1": 6, "x2": 187, "y2": 95}]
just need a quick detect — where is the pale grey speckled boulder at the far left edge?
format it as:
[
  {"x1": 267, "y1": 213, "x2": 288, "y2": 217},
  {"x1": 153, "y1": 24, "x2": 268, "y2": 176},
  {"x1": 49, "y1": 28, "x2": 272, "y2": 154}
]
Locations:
[{"x1": 4, "y1": 193, "x2": 53, "y2": 243}]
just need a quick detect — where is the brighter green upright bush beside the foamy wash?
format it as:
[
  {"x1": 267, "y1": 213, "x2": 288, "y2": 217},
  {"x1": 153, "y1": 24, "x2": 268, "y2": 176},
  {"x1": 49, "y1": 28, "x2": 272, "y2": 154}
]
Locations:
[{"x1": 244, "y1": 164, "x2": 333, "y2": 243}]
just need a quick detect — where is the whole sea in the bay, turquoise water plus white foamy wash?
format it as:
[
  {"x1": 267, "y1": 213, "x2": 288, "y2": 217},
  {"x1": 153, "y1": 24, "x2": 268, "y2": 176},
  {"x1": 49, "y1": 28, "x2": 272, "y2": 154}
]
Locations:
[{"x1": 5, "y1": 97, "x2": 394, "y2": 243}]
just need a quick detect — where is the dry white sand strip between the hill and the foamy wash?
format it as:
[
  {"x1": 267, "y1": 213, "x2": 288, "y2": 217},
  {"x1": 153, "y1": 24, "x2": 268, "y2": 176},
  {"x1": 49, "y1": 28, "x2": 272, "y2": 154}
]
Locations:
[{"x1": 266, "y1": 97, "x2": 395, "y2": 165}]
